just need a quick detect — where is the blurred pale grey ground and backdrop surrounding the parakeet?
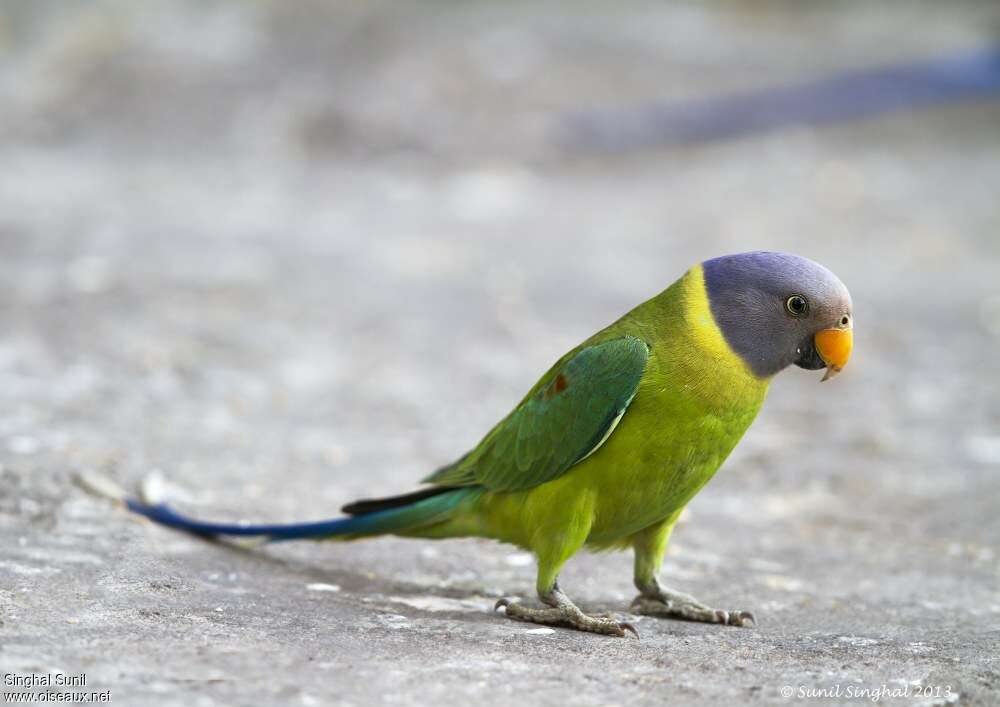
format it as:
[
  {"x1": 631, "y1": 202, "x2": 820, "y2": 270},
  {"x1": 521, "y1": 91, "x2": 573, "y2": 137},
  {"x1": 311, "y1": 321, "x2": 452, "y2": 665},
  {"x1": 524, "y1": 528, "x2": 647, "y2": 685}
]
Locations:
[{"x1": 0, "y1": 0, "x2": 1000, "y2": 705}]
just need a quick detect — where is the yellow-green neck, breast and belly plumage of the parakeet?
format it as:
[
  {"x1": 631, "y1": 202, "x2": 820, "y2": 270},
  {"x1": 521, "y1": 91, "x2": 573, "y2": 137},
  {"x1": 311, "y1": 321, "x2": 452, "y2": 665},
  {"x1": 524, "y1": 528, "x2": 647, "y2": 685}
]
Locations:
[{"x1": 472, "y1": 265, "x2": 769, "y2": 549}]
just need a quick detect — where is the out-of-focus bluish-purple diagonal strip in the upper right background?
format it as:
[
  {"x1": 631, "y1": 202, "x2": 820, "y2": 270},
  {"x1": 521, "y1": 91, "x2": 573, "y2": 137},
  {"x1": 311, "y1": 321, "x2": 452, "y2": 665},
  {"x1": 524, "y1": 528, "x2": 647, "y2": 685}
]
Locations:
[{"x1": 561, "y1": 45, "x2": 1000, "y2": 151}]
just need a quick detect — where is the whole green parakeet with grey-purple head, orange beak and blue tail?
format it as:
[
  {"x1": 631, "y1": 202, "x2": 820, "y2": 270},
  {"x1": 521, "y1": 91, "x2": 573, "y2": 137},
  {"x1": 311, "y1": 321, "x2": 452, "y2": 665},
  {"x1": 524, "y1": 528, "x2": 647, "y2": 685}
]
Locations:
[{"x1": 119, "y1": 251, "x2": 853, "y2": 636}]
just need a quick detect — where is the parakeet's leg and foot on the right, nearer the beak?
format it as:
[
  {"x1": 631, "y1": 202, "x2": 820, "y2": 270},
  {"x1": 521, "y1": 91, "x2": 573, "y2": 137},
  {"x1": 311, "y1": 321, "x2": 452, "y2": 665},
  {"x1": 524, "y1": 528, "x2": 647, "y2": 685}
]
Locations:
[{"x1": 631, "y1": 511, "x2": 756, "y2": 626}]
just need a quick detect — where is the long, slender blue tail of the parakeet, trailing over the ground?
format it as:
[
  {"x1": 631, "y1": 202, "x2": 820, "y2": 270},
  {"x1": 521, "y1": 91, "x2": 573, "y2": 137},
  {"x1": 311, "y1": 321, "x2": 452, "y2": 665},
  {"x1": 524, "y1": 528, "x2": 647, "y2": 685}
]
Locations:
[{"x1": 125, "y1": 487, "x2": 482, "y2": 542}]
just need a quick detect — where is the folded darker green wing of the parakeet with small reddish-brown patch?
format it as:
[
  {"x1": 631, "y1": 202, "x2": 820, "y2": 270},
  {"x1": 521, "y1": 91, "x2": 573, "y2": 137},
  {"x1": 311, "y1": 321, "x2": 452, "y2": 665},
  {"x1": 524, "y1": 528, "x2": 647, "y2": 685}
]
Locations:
[{"x1": 424, "y1": 336, "x2": 649, "y2": 491}]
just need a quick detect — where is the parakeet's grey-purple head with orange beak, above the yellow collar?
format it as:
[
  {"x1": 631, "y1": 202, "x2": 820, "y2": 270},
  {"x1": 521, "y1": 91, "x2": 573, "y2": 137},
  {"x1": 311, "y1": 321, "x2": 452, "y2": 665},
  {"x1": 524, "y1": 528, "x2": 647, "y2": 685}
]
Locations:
[{"x1": 702, "y1": 251, "x2": 854, "y2": 380}]
